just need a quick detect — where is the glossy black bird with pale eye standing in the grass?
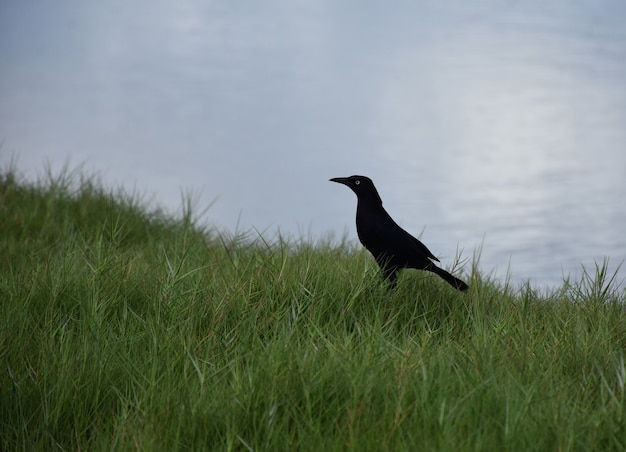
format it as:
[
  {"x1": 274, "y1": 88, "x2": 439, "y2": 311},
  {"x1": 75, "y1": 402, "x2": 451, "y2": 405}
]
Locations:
[{"x1": 330, "y1": 176, "x2": 468, "y2": 291}]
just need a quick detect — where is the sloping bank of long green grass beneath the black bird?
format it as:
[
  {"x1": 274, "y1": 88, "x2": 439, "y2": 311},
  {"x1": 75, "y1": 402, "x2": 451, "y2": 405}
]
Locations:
[{"x1": 0, "y1": 170, "x2": 626, "y2": 451}]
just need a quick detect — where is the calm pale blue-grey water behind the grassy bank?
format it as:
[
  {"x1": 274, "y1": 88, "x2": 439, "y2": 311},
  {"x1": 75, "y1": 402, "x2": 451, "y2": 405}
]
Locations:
[{"x1": 0, "y1": 0, "x2": 626, "y2": 286}]
